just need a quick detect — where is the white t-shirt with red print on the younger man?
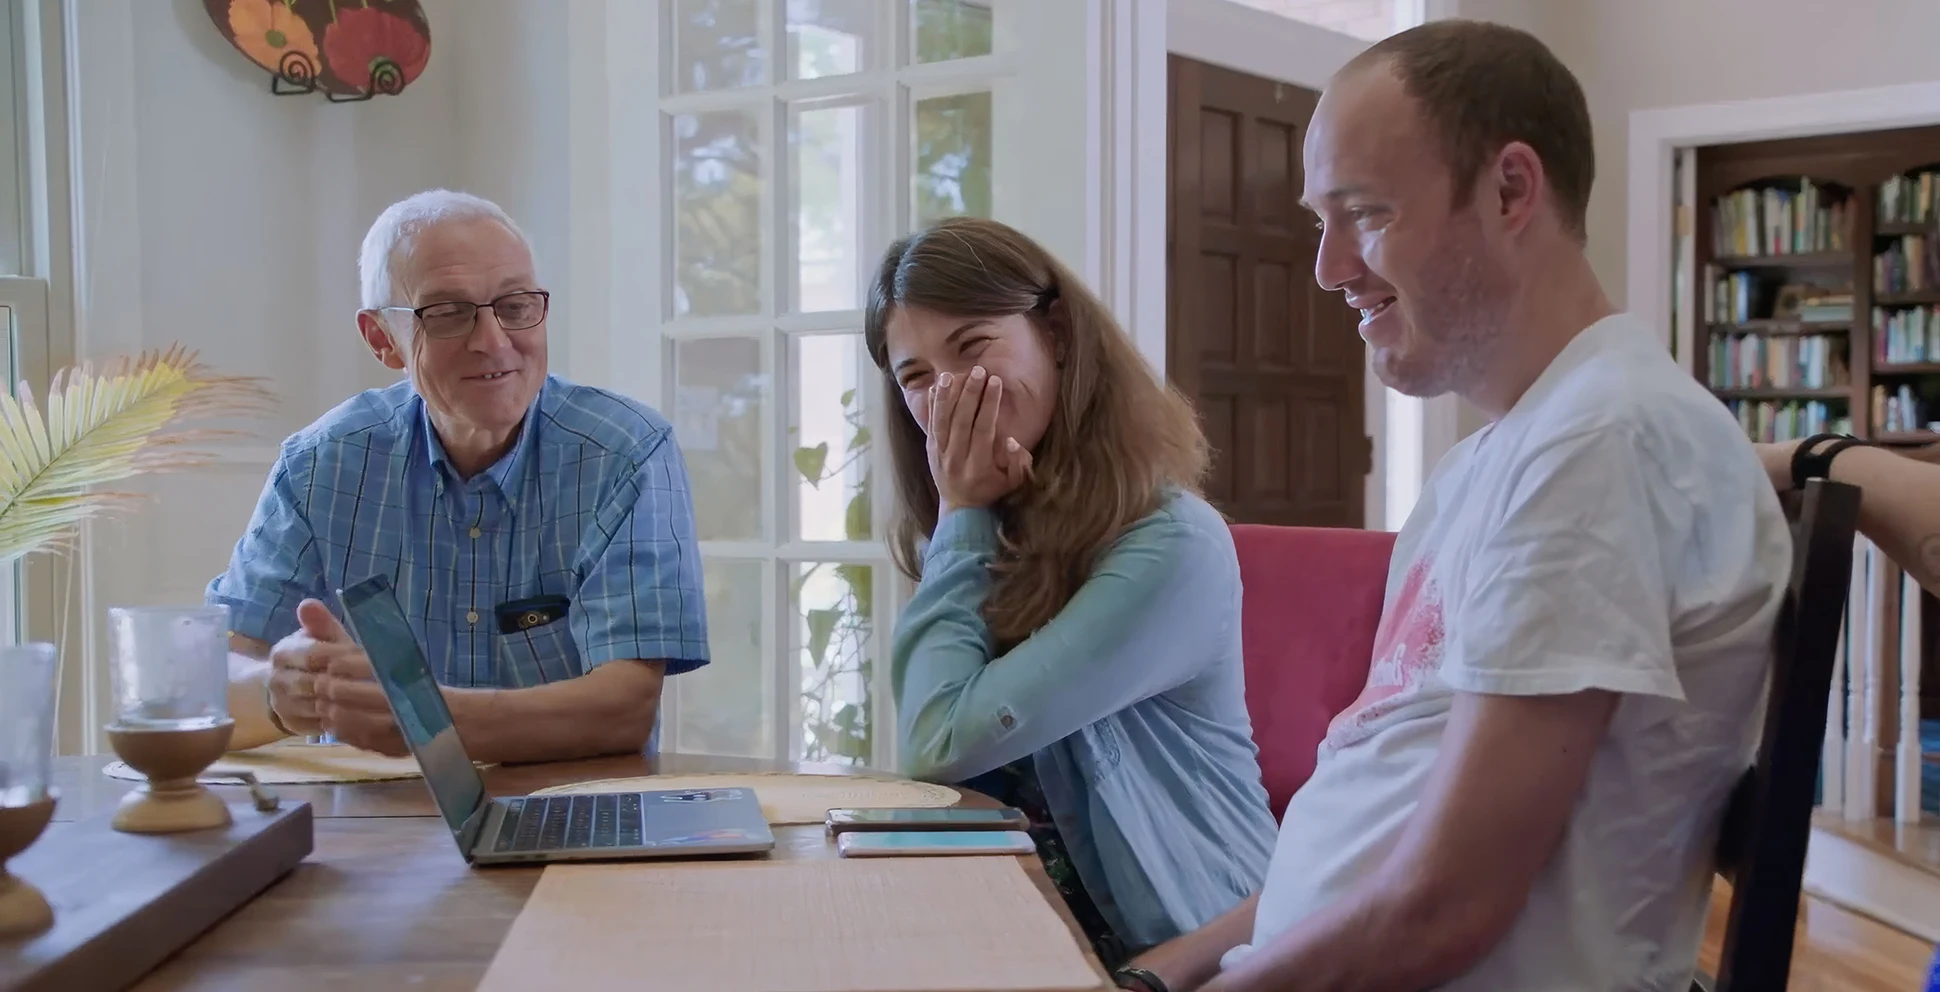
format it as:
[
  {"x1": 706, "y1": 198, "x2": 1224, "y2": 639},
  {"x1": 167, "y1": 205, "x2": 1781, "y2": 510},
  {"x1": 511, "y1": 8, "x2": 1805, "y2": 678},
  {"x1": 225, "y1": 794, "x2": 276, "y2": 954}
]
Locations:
[{"x1": 1224, "y1": 314, "x2": 1793, "y2": 992}]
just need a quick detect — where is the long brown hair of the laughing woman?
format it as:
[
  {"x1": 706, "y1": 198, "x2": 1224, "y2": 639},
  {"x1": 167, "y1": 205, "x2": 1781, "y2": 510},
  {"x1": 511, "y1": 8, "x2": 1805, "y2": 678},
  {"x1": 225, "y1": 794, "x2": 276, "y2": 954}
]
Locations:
[{"x1": 863, "y1": 217, "x2": 1209, "y2": 650}]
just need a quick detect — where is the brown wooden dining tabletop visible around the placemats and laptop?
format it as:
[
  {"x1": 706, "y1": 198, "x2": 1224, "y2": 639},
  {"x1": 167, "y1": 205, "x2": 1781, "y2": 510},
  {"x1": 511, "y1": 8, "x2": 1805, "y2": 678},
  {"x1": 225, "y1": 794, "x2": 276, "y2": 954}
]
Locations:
[{"x1": 37, "y1": 753, "x2": 1114, "y2": 992}]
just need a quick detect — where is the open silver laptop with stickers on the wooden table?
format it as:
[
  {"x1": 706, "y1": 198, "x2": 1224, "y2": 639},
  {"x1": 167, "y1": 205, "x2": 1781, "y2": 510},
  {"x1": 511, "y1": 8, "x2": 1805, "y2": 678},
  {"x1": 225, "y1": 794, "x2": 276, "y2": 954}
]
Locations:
[{"x1": 338, "y1": 575, "x2": 774, "y2": 864}]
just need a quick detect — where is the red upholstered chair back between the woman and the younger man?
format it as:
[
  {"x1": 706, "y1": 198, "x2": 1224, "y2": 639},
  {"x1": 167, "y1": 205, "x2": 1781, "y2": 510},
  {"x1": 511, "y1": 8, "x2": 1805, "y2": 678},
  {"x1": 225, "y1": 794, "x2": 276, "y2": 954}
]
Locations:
[{"x1": 1232, "y1": 524, "x2": 1395, "y2": 817}]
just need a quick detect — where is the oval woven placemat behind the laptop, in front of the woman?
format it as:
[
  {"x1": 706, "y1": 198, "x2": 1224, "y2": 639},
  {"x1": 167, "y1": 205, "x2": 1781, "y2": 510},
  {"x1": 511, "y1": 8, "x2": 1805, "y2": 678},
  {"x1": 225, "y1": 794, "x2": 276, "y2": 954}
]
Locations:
[{"x1": 534, "y1": 773, "x2": 960, "y2": 827}]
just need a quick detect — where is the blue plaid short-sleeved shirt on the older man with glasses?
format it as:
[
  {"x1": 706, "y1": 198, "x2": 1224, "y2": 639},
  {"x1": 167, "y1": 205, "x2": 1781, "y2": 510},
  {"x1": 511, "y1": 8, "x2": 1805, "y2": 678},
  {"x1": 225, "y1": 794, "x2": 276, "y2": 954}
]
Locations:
[{"x1": 208, "y1": 377, "x2": 708, "y2": 687}]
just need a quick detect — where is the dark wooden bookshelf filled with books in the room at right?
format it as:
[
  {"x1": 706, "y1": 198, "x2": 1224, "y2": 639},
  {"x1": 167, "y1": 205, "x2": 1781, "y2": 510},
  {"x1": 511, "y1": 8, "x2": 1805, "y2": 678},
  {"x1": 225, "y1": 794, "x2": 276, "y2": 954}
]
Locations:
[{"x1": 1692, "y1": 128, "x2": 1940, "y2": 445}]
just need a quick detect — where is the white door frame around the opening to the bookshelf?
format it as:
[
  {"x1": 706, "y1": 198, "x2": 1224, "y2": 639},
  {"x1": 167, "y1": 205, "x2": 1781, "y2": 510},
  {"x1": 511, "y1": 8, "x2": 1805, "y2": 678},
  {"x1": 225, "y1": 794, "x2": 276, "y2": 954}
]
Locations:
[{"x1": 1624, "y1": 82, "x2": 1940, "y2": 357}]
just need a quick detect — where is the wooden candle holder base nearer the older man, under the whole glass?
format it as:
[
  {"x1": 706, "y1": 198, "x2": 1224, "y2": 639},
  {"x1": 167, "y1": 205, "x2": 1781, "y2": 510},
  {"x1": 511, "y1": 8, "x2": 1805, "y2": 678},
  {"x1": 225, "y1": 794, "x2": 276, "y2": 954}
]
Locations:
[{"x1": 107, "y1": 720, "x2": 237, "y2": 833}]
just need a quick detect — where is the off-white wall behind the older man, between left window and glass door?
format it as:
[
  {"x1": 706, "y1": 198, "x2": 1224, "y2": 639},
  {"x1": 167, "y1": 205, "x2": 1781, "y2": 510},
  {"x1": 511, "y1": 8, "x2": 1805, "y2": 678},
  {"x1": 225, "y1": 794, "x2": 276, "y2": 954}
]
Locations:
[{"x1": 70, "y1": 0, "x2": 572, "y2": 745}]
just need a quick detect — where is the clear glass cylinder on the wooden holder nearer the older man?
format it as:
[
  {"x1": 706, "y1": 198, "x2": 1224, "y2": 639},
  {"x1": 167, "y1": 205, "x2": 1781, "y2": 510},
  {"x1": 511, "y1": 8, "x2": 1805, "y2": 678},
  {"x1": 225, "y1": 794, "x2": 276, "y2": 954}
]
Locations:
[{"x1": 109, "y1": 606, "x2": 229, "y2": 730}]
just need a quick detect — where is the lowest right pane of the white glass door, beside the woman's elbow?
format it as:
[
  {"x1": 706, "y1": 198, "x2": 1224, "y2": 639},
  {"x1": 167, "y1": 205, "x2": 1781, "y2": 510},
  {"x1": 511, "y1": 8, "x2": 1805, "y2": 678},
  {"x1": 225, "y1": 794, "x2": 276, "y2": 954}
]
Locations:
[{"x1": 790, "y1": 561, "x2": 875, "y2": 765}]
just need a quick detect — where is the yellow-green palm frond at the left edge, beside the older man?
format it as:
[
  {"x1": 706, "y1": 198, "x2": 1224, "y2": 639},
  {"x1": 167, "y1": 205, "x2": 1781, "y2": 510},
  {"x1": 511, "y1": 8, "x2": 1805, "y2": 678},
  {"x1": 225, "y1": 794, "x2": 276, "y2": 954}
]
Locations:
[{"x1": 0, "y1": 346, "x2": 272, "y2": 563}]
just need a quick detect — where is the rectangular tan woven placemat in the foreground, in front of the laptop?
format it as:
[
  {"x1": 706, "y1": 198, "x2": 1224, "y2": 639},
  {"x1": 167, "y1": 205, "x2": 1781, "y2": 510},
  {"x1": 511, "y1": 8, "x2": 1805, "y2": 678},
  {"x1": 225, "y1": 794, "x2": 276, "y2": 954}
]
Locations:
[{"x1": 479, "y1": 856, "x2": 1110, "y2": 992}]
